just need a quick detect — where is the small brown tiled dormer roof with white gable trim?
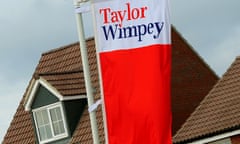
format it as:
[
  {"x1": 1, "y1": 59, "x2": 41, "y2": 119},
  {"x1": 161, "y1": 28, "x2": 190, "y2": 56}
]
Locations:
[{"x1": 24, "y1": 72, "x2": 86, "y2": 111}]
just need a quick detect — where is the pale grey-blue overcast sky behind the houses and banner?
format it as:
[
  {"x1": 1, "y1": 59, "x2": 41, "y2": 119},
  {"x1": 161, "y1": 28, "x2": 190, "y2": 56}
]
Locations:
[{"x1": 0, "y1": 0, "x2": 240, "y2": 142}]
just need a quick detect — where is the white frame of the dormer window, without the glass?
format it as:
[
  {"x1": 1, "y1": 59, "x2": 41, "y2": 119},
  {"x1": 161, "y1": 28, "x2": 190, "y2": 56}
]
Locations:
[{"x1": 32, "y1": 102, "x2": 68, "y2": 144}]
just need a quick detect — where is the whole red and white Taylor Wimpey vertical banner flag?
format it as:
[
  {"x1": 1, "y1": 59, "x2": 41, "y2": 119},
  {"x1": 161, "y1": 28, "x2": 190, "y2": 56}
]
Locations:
[{"x1": 93, "y1": 0, "x2": 172, "y2": 144}]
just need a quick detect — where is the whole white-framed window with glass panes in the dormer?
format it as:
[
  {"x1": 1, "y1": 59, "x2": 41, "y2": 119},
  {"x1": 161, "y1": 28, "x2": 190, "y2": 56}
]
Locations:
[{"x1": 33, "y1": 103, "x2": 68, "y2": 143}]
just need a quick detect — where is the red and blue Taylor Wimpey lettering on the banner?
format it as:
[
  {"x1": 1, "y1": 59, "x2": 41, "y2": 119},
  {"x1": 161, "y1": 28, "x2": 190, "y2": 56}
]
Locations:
[{"x1": 99, "y1": 3, "x2": 164, "y2": 42}]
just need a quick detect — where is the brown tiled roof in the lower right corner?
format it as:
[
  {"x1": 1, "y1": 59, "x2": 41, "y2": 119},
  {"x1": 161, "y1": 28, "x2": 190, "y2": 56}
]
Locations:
[{"x1": 173, "y1": 57, "x2": 240, "y2": 143}]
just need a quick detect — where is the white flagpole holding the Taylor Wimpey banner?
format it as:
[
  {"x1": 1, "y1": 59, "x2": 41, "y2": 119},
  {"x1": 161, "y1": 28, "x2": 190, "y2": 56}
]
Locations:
[{"x1": 74, "y1": 0, "x2": 99, "y2": 144}]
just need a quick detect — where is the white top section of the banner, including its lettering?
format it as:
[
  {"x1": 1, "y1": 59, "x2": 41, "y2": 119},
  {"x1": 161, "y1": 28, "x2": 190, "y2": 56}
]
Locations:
[{"x1": 94, "y1": 0, "x2": 171, "y2": 52}]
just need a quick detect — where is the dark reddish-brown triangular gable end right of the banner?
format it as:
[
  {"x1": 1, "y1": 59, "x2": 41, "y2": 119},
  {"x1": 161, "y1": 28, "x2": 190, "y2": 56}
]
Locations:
[{"x1": 171, "y1": 29, "x2": 218, "y2": 135}]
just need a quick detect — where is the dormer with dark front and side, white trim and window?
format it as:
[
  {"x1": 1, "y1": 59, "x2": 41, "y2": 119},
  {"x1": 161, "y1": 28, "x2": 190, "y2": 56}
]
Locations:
[{"x1": 24, "y1": 77, "x2": 87, "y2": 144}]
